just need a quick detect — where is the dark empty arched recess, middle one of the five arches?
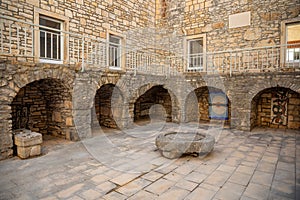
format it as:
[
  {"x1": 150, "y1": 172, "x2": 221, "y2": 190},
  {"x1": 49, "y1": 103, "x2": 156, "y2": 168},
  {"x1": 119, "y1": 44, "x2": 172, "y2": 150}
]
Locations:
[{"x1": 134, "y1": 85, "x2": 172, "y2": 123}]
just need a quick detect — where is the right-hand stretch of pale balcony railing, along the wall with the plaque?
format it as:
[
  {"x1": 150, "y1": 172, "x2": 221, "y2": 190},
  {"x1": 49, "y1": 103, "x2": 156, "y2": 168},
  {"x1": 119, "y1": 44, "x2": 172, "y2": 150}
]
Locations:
[{"x1": 186, "y1": 44, "x2": 300, "y2": 74}]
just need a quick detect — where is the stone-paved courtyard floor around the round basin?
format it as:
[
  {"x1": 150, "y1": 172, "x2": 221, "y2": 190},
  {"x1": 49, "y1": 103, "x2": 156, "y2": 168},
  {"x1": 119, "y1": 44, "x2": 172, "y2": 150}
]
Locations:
[{"x1": 0, "y1": 124, "x2": 300, "y2": 200}]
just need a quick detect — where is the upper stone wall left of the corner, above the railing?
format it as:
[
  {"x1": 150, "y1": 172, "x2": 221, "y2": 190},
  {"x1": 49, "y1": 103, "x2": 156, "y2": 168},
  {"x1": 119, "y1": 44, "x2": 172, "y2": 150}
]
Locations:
[{"x1": 0, "y1": 0, "x2": 155, "y2": 38}]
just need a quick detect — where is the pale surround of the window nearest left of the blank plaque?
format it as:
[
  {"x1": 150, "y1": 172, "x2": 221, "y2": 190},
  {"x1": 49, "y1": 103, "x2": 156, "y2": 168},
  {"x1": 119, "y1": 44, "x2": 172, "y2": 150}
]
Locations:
[{"x1": 184, "y1": 34, "x2": 206, "y2": 71}]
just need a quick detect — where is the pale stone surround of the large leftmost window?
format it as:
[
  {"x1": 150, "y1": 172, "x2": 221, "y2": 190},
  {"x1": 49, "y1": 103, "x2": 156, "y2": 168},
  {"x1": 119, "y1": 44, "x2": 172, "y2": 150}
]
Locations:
[{"x1": 34, "y1": 7, "x2": 70, "y2": 64}]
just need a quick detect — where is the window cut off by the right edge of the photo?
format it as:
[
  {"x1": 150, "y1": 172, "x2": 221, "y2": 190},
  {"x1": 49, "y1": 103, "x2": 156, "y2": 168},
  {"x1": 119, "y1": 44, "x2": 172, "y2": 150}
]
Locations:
[{"x1": 286, "y1": 23, "x2": 300, "y2": 62}]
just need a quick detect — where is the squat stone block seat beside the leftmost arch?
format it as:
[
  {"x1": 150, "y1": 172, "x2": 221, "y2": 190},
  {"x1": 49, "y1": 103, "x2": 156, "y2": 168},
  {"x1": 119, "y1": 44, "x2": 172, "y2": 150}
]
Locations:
[{"x1": 14, "y1": 129, "x2": 43, "y2": 159}]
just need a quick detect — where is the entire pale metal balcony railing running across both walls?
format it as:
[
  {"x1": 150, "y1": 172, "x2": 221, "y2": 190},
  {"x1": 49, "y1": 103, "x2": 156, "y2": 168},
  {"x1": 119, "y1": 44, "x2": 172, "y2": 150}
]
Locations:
[{"x1": 0, "y1": 16, "x2": 300, "y2": 76}]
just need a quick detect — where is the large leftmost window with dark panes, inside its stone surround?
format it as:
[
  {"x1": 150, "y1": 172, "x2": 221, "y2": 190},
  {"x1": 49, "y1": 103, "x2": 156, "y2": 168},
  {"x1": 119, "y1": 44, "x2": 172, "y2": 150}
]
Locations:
[{"x1": 39, "y1": 15, "x2": 63, "y2": 63}]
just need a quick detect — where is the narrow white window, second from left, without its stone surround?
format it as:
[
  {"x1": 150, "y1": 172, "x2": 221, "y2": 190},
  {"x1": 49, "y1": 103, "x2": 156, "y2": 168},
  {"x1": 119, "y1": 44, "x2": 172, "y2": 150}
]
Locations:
[{"x1": 108, "y1": 34, "x2": 122, "y2": 69}]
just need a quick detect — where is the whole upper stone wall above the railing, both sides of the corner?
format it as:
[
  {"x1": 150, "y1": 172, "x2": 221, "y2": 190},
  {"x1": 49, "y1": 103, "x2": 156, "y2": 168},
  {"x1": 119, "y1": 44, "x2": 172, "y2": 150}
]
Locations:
[{"x1": 0, "y1": 0, "x2": 300, "y2": 56}]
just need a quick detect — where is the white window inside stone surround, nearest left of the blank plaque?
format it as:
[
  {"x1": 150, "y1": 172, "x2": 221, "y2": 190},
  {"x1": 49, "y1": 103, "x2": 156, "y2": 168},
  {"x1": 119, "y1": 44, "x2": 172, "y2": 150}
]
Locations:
[{"x1": 188, "y1": 38, "x2": 203, "y2": 70}]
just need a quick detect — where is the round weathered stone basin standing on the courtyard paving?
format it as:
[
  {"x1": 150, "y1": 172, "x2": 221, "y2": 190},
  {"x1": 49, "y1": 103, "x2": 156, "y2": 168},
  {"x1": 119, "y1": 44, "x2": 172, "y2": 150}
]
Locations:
[{"x1": 155, "y1": 132, "x2": 215, "y2": 159}]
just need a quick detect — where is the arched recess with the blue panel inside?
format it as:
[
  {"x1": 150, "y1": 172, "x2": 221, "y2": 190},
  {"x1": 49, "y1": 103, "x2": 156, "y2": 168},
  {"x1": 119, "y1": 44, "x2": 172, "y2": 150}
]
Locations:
[{"x1": 185, "y1": 86, "x2": 231, "y2": 125}]
